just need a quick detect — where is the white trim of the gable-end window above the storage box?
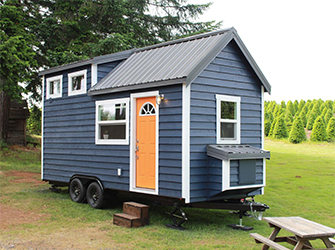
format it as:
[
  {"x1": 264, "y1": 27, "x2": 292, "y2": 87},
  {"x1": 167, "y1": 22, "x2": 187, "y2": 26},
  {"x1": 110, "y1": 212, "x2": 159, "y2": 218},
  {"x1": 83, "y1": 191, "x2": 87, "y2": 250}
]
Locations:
[{"x1": 216, "y1": 94, "x2": 241, "y2": 144}]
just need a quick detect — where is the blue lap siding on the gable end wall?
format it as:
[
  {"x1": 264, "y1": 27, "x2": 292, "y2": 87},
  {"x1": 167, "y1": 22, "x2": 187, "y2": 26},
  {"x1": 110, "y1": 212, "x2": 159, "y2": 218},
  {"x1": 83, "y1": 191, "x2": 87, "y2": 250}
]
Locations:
[{"x1": 190, "y1": 42, "x2": 262, "y2": 202}]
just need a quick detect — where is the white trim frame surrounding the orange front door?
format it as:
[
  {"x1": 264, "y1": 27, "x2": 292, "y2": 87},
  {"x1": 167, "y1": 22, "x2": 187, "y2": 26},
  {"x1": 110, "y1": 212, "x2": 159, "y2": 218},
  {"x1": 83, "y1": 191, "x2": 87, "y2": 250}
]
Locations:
[{"x1": 129, "y1": 91, "x2": 159, "y2": 195}]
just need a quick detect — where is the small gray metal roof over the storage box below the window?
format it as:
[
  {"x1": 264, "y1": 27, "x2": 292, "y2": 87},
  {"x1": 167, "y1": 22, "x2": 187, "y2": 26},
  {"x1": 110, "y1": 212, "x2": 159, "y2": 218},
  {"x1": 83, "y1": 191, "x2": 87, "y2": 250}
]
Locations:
[{"x1": 207, "y1": 144, "x2": 270, "y2": 161}]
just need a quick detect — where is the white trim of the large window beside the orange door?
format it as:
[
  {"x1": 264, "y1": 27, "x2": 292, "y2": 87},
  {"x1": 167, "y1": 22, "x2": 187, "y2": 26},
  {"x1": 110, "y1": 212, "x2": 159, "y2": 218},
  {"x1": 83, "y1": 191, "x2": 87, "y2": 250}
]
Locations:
[{"x1": 95, "y1": 98, "x2": 129, "y2": 145}]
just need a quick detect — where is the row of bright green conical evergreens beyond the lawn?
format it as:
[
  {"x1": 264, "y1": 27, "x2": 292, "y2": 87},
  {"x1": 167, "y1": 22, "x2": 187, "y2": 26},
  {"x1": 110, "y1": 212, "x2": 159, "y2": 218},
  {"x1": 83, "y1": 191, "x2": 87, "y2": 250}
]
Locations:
[{"x1": 264, "y1": 99, "x2": 335, "y2": 143}]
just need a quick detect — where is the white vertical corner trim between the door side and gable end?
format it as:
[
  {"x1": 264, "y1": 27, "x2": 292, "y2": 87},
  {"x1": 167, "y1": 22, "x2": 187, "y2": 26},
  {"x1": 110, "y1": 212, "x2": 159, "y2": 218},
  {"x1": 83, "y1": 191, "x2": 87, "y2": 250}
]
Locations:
[{"x1": 182, "y1": 83, "x2": 191, "y2": 203}]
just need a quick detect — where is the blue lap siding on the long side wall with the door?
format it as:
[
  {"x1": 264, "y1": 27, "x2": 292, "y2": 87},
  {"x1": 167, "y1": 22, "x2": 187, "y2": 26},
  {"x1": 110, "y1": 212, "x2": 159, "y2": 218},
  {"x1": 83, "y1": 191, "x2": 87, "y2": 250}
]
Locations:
[{"x1": 43, "y1": 63, "x2": 182, "y2": 198}]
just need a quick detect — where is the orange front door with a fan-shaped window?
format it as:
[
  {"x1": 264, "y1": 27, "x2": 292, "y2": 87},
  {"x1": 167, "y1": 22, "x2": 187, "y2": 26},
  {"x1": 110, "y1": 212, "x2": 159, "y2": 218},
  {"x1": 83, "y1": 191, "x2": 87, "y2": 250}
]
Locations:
[{"x1": 136, "y1": 97, "x2": 156, "y2": 189}]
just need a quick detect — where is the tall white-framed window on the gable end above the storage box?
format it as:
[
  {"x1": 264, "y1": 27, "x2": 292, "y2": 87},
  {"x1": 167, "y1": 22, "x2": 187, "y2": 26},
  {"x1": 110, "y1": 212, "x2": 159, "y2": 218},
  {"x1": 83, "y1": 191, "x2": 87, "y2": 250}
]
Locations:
[{"x1": 216, "y1": 95, "x2": 241, "y2": 144}]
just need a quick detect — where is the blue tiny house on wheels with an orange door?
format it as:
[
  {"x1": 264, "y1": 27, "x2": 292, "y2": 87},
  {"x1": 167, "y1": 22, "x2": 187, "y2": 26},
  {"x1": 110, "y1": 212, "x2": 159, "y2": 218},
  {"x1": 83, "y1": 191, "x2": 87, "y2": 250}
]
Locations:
[{"x1": 40, "y1": 28, "x2": 271, "y2": 208}]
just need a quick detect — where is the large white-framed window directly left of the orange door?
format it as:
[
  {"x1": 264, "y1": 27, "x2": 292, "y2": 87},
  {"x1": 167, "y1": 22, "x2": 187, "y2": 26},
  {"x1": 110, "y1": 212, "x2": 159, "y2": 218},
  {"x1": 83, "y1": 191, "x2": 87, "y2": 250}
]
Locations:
[{"x1": 95, "y1": 98, "x2": 129, "y2": 144}]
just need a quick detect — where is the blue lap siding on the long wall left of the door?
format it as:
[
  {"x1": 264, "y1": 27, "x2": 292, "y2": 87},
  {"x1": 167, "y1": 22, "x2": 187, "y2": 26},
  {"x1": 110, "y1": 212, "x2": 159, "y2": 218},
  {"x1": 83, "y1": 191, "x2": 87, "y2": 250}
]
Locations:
[{"x1": 43, "y1": 63, "x2": 130, "y2": 190}]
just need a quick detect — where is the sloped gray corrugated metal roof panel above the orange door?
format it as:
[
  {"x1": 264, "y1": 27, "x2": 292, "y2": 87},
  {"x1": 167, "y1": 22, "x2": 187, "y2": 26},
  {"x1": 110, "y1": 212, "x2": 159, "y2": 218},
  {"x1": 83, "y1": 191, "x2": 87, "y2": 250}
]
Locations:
[{"x1": 90, "y1": 30, "x2": 229, "y2": 94}]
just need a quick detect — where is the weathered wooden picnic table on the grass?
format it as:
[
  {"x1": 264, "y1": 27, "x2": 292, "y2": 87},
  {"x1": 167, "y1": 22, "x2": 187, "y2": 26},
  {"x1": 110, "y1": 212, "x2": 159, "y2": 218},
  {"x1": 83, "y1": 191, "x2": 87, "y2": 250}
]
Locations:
[{"x1": 250, "y1": 217, "x2": 335, "y2": 250}]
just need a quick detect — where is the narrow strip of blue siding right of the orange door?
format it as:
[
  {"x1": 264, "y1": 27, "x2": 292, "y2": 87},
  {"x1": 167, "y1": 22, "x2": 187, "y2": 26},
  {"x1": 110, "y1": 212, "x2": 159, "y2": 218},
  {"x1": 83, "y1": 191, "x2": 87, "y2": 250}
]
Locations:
[{"x1": 159, "y1": 85, "x2": 182, "y2": 198}]
